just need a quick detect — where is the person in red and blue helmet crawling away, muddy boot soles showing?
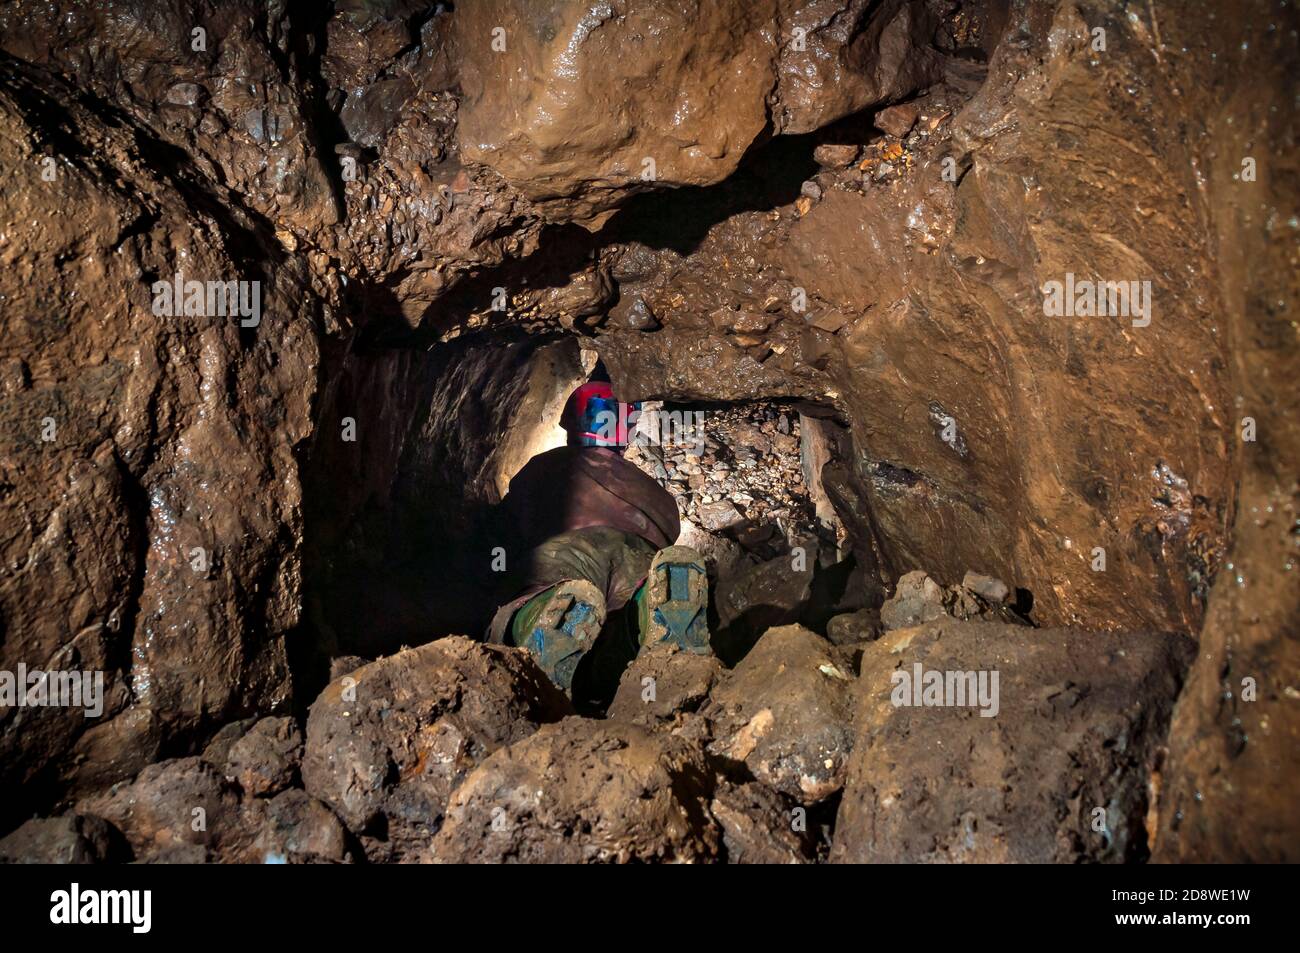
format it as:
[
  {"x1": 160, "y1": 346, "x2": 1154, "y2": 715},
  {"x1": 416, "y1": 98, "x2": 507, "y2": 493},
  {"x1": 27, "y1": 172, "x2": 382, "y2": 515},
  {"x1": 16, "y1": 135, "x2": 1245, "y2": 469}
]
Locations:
[{"x1": 489, "y1": 371, "x2": 710, "y2": 692}]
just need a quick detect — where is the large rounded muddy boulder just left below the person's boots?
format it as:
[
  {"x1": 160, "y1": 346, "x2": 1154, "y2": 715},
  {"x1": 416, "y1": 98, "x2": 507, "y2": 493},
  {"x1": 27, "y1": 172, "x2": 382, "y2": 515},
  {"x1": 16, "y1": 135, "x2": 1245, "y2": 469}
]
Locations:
[{"x1": 303, "y1": 636, "x2": 571, "y2": 859}]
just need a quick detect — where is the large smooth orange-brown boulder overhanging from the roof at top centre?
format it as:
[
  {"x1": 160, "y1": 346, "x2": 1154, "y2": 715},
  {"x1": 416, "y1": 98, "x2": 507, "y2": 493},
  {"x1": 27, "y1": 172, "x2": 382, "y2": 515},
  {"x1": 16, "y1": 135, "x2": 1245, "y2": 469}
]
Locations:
[{"x1": 451, "y1": 0, "x2": 775, "y2": 221}]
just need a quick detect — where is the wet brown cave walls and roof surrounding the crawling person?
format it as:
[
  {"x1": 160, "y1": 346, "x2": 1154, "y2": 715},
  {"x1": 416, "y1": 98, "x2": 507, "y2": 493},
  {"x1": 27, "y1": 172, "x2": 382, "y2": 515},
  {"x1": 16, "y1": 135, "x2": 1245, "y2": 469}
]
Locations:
[{"x1": 0, "y1": 0, "x2": 1300, "y2": 859}]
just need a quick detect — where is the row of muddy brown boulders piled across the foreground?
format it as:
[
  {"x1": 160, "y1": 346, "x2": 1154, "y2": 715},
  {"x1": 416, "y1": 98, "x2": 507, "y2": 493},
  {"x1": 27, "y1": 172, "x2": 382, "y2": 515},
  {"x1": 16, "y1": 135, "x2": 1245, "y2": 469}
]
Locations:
[{"x1": 0, "y1": 587, "x2": 1192, "y2": 863}]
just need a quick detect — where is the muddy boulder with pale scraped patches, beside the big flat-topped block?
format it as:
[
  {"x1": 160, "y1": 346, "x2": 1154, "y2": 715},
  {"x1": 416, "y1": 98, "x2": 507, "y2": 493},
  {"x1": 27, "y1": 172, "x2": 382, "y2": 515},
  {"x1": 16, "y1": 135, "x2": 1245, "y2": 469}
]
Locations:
[{"x1": 702, "y1": 625, "x2": 853, "y2": 805}]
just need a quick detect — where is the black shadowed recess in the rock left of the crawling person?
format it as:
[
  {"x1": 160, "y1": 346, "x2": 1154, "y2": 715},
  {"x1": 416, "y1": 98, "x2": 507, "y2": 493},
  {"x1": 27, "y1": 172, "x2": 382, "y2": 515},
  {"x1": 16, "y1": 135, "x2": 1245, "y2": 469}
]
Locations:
[{"x1": 289, "y1": 319, "x2": 564, "y2": 699}]
